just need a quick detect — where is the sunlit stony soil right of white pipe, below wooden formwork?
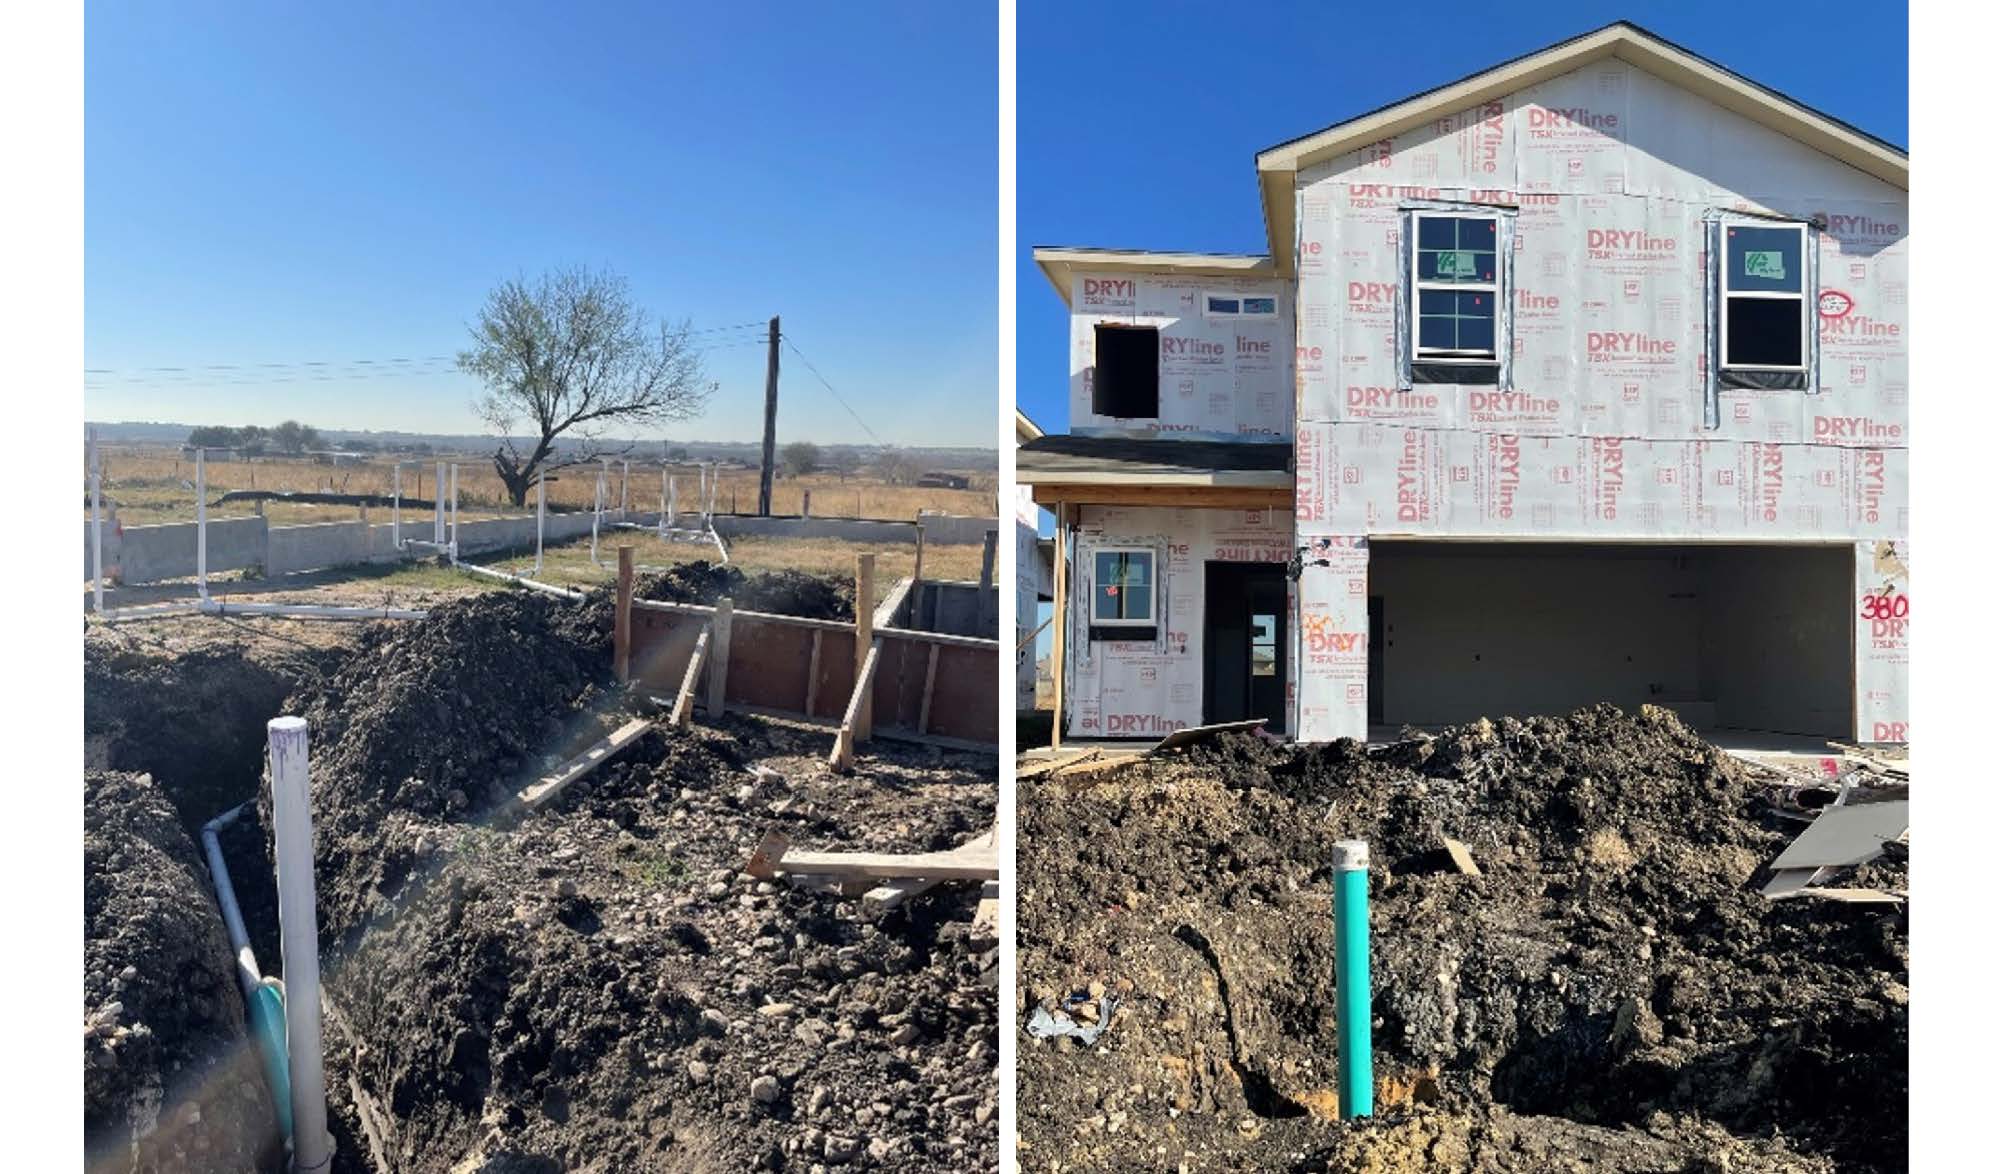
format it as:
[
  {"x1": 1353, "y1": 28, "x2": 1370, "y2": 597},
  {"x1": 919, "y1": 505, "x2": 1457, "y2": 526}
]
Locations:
[{"x1": 329, "y1": 719, "x2": 998, "y2": 1172}]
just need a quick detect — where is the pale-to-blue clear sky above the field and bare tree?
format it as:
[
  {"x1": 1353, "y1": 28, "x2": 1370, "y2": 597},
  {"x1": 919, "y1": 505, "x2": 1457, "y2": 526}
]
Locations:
[{"x1": 84, "y1": 0, "x2": 998, "y2": 447}]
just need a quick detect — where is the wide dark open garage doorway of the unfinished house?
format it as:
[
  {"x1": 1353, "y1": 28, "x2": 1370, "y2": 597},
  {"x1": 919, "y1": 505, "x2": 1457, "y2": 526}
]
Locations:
[{"x1": 1367, "y1": 541, "x2": 1856, "y2": 737}]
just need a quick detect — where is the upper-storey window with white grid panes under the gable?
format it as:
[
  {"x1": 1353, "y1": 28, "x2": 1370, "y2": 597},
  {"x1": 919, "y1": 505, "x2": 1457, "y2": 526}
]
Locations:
[{"x1": 1413, "y1": 212, "x2": 1503, "y2": 363}]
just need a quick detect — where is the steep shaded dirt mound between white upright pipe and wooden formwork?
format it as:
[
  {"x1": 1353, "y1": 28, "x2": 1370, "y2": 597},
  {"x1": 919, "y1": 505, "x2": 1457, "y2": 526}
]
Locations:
[{"x1": 273, "y1": 591, "x2": 619, "y2": 940}]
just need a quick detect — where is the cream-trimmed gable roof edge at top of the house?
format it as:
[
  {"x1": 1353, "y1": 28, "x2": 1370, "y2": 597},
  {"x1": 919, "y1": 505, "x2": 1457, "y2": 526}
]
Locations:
[{"x1": 1255, "y1": 20, "x2": 1906, "y2": 276}]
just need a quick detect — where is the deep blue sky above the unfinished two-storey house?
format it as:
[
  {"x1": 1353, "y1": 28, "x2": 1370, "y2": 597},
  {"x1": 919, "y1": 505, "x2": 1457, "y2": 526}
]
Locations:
[{"x1": 1018, "y1": 0, "x2": 1906, "y2": 431}]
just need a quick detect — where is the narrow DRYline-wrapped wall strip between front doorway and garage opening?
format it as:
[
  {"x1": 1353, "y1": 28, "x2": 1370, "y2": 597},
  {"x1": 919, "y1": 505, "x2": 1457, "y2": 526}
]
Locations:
[{"x1": 1295, "y1": 535, "x2": 1371, "y2": 743}]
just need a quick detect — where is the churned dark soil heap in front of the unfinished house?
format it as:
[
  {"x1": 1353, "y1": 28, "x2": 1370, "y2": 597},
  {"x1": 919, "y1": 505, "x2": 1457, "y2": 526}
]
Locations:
[{"x1": 1018, "y1": 707, "x2": 1906, "y2": 1172}]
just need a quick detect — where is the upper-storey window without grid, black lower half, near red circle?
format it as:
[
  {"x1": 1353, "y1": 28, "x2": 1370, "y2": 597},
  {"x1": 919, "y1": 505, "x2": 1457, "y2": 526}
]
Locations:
[{"x1": 1719, "y1": 224, "x2": 1808, "y2": 371}]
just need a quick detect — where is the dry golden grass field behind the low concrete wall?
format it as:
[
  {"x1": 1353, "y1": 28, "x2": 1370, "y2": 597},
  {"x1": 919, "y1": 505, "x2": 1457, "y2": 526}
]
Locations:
[{"x1": 84, "y1": 447, "x2": 998, "y2": 525}]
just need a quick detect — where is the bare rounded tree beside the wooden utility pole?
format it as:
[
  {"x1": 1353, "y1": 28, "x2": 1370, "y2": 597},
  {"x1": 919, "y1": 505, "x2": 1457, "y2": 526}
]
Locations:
[{"x1": 457, "y1": 266, "x2": 715, "y2": 505}]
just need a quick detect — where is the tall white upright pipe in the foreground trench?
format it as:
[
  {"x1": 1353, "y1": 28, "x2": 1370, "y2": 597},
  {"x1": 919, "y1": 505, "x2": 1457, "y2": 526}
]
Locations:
[{"x1": 269, "y1": 717, "x2": 333, "y2": 1174}]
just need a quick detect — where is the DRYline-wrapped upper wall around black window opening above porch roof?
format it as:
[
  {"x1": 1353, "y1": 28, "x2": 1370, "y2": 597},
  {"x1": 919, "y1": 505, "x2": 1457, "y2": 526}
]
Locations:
[{"x1": 1068, "y1": 274, "x2": 1295, "y2": 443}]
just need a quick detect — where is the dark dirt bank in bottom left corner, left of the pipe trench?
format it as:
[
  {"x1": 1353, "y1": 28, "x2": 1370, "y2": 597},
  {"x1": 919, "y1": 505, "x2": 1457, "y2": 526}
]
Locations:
[{"x1": 84, "y1": 771, "x2": 281, "y2": 1172}]
